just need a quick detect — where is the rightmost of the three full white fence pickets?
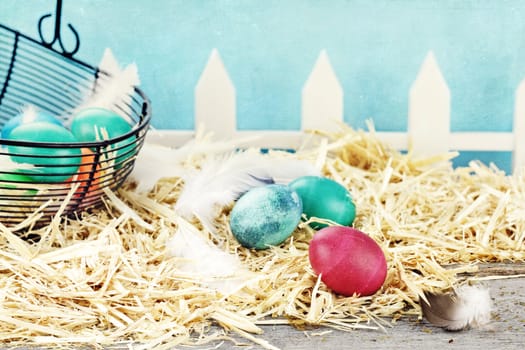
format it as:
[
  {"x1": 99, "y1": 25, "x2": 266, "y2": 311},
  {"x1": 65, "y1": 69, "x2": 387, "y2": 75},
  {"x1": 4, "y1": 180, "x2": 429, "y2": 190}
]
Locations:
[{"x1": 408, "y1": 51, "x2": 450, "y2": 155}]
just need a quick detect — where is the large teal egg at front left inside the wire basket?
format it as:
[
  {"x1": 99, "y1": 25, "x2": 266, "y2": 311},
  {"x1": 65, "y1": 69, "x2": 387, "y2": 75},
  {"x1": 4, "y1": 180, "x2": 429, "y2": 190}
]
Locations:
[{"x1": 7, "y1": 122, "x2": 81, "y2": 182}]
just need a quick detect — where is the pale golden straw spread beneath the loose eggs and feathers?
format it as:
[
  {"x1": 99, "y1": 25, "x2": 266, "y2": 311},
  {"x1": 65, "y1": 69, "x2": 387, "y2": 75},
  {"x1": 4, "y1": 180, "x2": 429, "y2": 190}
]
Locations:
[{"x1": 0, "y1": 127, "x2": 525, "y2": 348}]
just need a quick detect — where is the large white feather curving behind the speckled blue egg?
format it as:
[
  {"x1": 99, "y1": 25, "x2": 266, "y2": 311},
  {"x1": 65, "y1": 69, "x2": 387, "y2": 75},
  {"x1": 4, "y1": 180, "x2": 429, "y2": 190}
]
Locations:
[{"x1": 175, "y1": 151, "x2": 319, "y2": 232}]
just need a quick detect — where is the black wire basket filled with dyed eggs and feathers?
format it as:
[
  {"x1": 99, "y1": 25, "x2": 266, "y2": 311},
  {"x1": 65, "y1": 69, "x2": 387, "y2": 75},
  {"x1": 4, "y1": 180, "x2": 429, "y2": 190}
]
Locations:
[{"x1": 0, "y1": 24, "x2": 151, "y2": 227}]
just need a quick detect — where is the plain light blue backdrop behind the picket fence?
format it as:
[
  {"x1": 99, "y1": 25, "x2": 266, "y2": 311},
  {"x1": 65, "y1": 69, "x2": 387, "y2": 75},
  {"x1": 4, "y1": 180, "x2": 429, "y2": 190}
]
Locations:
[{"x1": 0, "y1": 0, "x2": 525, "y2": 169}]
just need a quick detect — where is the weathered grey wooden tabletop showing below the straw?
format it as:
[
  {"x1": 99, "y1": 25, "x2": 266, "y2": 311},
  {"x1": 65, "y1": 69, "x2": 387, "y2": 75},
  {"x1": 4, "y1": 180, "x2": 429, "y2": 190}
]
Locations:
[{"x1": 222, "y1": 265, "x2": 525, "y2": 350}]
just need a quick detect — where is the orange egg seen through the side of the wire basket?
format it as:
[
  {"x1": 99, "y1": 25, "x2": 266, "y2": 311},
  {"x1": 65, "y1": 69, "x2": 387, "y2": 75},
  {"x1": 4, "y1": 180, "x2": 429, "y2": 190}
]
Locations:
[{"x1": 67, "y1": 148, "x2": 102, "y2": 197}]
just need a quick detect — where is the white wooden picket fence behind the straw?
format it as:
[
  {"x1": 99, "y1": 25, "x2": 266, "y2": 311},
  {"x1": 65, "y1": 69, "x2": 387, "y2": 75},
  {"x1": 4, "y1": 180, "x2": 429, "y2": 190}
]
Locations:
[{"x1": 145, "y1": 49, "x2": 525, "y2": 170}]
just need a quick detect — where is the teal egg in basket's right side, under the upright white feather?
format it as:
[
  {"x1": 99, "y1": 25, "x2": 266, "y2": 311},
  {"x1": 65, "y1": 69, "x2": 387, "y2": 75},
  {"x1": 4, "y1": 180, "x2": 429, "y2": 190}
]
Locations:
[{"x1": 71, "y1": 108, "x2": 135, "y2": 163}]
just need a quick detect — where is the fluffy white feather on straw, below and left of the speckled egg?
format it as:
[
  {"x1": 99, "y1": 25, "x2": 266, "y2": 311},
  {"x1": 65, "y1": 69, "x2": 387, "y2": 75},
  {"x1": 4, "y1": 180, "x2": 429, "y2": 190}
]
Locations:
[{"x1": 166, "y1": 217, "x2": 252, "y2": 295}]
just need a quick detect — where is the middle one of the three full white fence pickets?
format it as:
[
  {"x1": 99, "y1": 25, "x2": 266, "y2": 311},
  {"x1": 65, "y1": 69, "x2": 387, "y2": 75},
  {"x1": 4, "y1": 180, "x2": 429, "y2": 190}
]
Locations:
[{"x1": 301, "y1": 50, "x2": 343, "y2": 131}]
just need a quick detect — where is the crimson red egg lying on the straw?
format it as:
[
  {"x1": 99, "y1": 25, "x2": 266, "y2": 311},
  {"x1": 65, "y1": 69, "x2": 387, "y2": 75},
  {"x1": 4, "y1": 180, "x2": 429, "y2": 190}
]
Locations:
[{"x1": 308, "y1": 226, "x2": 387, "y2": 296}]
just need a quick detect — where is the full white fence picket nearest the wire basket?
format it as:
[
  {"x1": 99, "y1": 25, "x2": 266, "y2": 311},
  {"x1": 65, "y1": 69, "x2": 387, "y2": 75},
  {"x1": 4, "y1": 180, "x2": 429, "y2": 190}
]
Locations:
[{"x1": 195, "y1": 49, "x2": 237, "y2": 139}]
